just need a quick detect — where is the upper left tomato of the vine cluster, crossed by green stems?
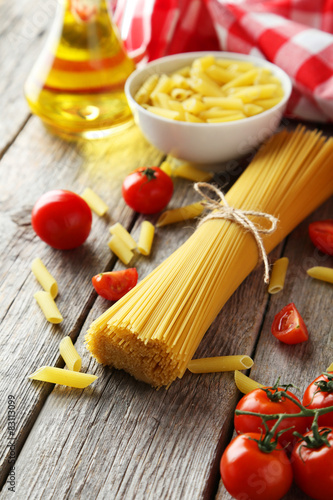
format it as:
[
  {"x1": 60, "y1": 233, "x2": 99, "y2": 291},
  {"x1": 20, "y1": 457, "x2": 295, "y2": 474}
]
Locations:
[{"x1": 234, "y1": 387, "x2": 311, "y2": 450}]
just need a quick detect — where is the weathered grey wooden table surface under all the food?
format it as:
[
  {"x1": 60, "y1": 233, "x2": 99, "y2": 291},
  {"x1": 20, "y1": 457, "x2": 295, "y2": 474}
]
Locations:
[{"x1": 0, "y1": 0, "x2": 333, "y2": 500}]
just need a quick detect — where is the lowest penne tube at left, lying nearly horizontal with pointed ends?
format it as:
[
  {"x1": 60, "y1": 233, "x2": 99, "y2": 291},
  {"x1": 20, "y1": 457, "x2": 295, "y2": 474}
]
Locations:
[{"x1": 29, "y1": 366, "x2": 97, "y2": 389}]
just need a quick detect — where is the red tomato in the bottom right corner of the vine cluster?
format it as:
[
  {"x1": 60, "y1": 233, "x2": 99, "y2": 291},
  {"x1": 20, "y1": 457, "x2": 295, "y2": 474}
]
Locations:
[{"x1": 290, "y1": 427, "x2": 333, "y2": 500}]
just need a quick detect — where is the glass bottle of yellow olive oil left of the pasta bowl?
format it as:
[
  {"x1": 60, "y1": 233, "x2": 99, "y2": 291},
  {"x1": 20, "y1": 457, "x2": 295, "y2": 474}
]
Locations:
[{"x1": 25, "y1": 0, "x2": 135, "y2": 138}]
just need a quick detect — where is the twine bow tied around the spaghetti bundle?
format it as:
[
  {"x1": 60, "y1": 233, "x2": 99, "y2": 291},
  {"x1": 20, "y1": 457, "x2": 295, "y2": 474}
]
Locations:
[{"x1": 194, "y1": 182, "x2": 278, "y2": 283}]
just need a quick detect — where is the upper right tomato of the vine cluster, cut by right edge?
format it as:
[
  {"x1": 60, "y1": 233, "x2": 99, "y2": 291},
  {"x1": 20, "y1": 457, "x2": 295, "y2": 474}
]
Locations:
[{"x1": 303, "y1": 372, "x2": 333, "y2": 426}]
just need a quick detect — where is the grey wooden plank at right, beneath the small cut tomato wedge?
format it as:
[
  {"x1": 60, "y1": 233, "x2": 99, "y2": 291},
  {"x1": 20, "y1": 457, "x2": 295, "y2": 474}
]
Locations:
[{"x1": 216, "y1": 199, "x2": 333, "y2": 500}]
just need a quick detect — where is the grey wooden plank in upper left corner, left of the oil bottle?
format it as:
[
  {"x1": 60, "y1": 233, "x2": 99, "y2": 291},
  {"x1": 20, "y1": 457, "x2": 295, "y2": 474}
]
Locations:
[{"x1": 0, "y1": 0, "x2": 57, "y2": 156}]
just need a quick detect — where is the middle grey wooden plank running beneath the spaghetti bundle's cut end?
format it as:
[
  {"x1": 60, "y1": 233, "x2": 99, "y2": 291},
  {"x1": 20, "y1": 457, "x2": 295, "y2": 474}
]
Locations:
[{"x1": 3, "y1": 165, "x2": 281, "y2": 499}]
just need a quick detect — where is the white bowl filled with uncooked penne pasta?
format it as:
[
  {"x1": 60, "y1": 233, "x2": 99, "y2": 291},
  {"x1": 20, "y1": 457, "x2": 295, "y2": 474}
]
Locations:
[{"x1": 125, "y1": 51, "x2": 292, "y2": 166}]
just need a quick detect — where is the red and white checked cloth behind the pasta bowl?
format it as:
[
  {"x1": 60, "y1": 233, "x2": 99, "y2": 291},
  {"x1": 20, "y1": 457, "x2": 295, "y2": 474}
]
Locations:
[{"x1": 114, "y1": 0, "x2": 333, "y2": 122}]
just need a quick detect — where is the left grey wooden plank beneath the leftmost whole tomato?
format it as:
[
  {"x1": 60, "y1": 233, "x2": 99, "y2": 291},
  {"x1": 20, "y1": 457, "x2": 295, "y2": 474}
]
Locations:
[{"x1": 0, "y1": 117, "x2": 161, "y2": 481}]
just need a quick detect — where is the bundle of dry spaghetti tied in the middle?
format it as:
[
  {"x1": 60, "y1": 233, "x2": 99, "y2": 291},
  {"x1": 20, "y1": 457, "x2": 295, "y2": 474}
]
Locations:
[{"x1": 86, "y1": 127, "x2": 333, "y2": 387}]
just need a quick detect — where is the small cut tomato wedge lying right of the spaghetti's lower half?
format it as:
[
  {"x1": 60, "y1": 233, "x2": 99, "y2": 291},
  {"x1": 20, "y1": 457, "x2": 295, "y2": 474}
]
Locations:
[{"x1": 272, "y1": 302, "x2": 309, "y2": 344}]
